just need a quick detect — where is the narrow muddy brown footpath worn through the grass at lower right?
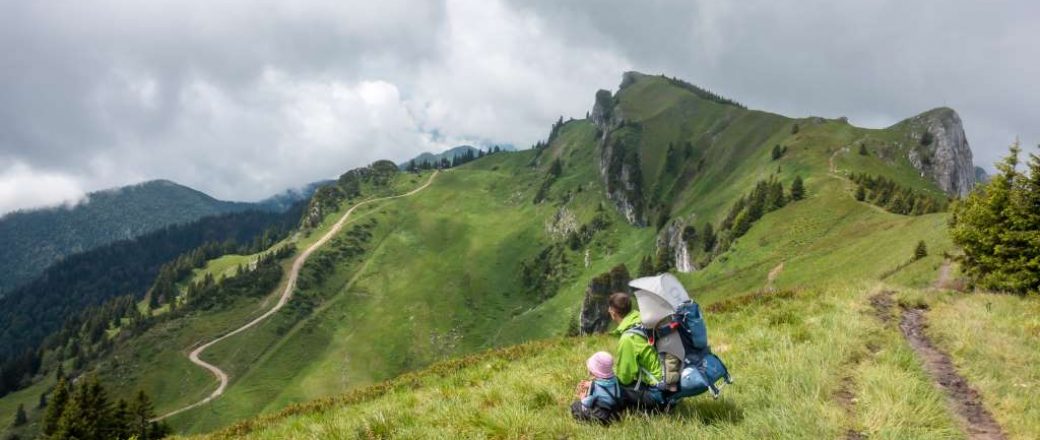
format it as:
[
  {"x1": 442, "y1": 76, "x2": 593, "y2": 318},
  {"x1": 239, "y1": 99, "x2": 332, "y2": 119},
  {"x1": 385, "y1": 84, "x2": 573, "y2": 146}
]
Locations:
[{"x1": 870, "y1": 291, "x2": 1007, "y2": 440}]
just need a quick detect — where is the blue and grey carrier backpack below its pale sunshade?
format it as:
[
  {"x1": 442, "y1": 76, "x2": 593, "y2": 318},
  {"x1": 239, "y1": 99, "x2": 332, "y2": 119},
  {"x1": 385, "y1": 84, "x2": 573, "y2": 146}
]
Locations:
[{"x1": 627, "y1": 301, "x2": 733, "y2": 404}]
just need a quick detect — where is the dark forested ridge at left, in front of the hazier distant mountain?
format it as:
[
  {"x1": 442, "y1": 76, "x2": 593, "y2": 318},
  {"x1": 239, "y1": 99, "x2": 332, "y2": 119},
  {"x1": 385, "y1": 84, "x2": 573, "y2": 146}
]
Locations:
[{"x1": 0, "y1": 203, "x2": 303, "y2": 401}]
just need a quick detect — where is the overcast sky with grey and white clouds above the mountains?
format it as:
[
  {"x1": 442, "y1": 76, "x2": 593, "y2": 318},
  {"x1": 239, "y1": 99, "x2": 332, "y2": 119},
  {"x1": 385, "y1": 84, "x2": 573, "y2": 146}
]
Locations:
[{"x1": 0, "y1": 0, "x2": 1040, "y2": 212}]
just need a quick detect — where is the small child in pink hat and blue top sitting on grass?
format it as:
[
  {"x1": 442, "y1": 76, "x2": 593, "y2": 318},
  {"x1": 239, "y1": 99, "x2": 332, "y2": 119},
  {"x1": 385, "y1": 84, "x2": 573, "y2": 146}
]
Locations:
[{"x1": 571, "y1": 352, "x2": 621, "y2": 424}]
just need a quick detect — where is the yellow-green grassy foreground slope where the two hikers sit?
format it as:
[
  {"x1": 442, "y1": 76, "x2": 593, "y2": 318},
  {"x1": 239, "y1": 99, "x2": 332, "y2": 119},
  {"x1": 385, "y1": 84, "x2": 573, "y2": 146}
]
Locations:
[{"x1": 196, "y1": 283, "x2": 973, "y2": 439}]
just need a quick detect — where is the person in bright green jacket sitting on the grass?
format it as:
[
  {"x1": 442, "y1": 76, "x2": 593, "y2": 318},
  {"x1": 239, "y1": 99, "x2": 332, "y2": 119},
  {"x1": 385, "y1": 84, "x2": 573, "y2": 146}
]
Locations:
[{"x1": 607, "y1": 292, "x2": 664, "y2": 408}]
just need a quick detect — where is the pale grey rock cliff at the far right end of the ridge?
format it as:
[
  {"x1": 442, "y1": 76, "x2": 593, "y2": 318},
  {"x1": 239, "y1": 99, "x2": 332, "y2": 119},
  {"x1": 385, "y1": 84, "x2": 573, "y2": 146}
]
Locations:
[{"x1": 905, "y1": 107, "x2": 976, "y2": 196}]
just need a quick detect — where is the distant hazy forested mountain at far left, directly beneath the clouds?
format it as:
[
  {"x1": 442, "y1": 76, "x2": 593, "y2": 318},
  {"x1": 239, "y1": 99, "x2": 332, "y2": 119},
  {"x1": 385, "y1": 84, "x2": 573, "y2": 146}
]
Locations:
[{"x1": 0, "y1": 180, "x2": 252, "y2": 296}]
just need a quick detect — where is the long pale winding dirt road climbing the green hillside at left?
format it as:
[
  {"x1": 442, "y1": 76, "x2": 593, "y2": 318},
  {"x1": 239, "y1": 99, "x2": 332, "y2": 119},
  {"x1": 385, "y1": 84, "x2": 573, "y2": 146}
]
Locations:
[{"x1": 155, "y1": 171, "x2": 439, "y2": 420}]
